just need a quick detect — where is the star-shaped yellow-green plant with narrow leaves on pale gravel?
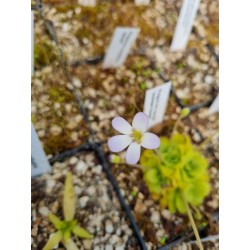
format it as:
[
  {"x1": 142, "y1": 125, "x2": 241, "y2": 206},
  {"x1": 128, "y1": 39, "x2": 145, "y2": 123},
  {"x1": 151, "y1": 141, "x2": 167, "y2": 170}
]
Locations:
[{"x1": 43, "y1": 173, "x2": 93, "y2": 250}]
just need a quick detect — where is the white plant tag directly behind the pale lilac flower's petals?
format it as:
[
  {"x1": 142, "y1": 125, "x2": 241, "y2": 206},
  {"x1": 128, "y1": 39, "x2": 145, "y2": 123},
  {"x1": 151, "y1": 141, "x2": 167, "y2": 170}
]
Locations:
[{"x1": 144, "y1": 82, "x2": 172, "y2": 127}]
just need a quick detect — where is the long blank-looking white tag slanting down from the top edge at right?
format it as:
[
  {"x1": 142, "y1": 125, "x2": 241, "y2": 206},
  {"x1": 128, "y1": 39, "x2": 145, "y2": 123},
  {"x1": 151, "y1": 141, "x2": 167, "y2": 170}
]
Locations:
[{"x1": 170, "y1": 0, "x2": 200, "y2": 51}]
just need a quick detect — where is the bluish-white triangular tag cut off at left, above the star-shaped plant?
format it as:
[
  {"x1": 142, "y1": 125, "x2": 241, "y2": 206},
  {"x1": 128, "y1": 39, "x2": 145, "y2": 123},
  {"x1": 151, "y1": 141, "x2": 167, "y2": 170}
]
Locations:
[{"x1": 31, "y1": 124, "x2": 51, "y2": 177}]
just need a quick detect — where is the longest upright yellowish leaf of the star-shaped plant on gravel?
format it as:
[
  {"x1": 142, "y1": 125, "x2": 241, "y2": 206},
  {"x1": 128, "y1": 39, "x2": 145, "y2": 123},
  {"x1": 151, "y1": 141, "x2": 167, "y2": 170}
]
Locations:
[{"x1": 63, "y1": 172, "x2": 76, "y2": 221}]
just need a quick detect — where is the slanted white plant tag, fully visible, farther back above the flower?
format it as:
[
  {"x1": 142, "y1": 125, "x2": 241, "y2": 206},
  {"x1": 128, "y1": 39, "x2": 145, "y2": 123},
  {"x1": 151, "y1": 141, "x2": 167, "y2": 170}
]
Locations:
[{"x1": 103, "y1": 27, "x2": 140, "y2": 68}]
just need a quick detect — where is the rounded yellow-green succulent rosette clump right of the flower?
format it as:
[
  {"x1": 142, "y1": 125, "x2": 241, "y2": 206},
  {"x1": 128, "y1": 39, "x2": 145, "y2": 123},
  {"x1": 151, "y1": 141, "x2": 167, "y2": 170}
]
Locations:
[{"x1": 141, "y1": 133, "x2": 210, "y2": 213}]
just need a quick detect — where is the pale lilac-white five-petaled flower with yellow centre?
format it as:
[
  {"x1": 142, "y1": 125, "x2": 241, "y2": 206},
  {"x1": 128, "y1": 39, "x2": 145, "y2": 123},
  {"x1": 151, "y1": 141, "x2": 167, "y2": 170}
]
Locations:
[{"x1": 108, "y1": 112, "x2": 160, "y2": 164}]
